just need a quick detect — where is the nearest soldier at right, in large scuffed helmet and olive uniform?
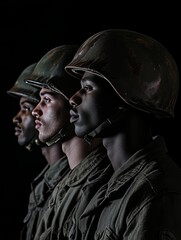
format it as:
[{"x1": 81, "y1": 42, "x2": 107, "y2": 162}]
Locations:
[{"x1": 65, "y1": 29, "x2": 181, "y2": 240}]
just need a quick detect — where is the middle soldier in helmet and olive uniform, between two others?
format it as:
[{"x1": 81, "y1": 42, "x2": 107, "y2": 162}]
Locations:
[{"x1": 26, "y1": 45, "x2": 113, "y2": 240}]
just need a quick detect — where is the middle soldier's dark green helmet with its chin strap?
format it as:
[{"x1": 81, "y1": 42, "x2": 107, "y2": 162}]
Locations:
[{"x1": 26, "y1": 45, "x2": 80, "y2": 146}]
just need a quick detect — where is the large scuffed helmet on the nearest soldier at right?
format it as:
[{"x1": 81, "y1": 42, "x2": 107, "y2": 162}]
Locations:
[{"x1": 65, "y1": 29, "x2": 179, "y2": 118}]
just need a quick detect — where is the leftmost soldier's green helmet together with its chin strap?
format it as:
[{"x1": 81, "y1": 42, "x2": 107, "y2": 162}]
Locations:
[{"x1": 7, "y1": 63, "x2": 43, "y2": 151}]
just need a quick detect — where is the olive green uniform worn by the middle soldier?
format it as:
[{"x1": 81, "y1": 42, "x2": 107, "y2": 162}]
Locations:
[{"x1": 31, "y1": 146, "x2": 113, "y2": 240}]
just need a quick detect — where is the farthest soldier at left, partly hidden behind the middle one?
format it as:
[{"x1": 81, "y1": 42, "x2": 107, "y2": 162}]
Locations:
[{"x1": 7, "y1": 63, "x2": 69, "y2": 240}]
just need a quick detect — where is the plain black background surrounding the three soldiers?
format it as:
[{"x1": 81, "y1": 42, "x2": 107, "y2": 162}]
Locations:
[{"x1": 0, "y1": 0, "x2": 181, "y2": 240}]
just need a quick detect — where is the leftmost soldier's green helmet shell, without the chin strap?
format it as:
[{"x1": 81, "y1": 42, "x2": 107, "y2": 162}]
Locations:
[{"x1": 7, "y1": 63, "x2": 39, "y2": 103}]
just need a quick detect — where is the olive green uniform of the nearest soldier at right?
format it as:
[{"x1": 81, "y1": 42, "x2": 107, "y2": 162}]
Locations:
[{"x1": 77, "y1": 137, "x2": 181, "y2": 240}]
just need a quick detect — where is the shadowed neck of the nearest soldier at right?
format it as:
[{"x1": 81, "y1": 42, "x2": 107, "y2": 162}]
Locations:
[{"x1": 103, "y1": 112, "x2": 152, "y2": 171}]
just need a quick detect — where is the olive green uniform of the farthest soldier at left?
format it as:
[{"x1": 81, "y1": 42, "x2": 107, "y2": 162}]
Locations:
[{"x1": 21, "y1": 156, "x2": 70, "y2": 240}]
